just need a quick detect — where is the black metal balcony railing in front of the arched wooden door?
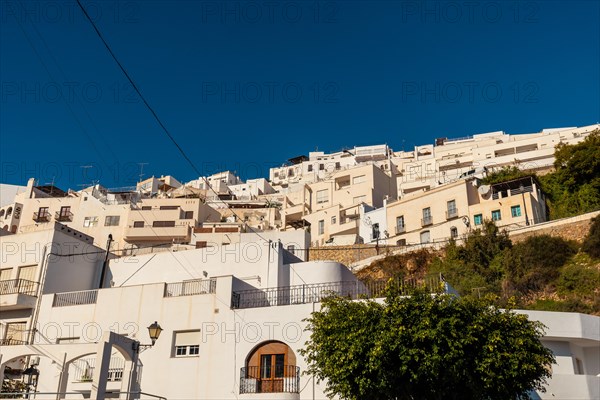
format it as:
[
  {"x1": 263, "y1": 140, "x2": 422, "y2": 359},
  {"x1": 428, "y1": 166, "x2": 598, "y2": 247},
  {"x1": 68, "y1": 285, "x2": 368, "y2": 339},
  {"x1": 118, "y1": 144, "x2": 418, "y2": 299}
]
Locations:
[{"x1": 240, "y1": 365, "x2": 300, "y2": 394}]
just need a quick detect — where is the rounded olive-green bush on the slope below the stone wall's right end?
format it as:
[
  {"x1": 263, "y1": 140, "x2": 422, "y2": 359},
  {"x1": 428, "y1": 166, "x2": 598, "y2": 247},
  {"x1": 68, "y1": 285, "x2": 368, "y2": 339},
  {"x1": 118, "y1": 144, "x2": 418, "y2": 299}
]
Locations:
[{"x1": 502, "y1": 235, "x2": 576, "y2": 295}]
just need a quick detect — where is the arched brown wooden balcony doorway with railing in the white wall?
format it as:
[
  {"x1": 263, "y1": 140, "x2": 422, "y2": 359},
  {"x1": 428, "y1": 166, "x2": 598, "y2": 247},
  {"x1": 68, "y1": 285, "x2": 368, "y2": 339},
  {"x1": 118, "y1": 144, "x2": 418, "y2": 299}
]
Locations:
[{"x1": 240, "y1": 340, "x2": 300, "y2": 393}]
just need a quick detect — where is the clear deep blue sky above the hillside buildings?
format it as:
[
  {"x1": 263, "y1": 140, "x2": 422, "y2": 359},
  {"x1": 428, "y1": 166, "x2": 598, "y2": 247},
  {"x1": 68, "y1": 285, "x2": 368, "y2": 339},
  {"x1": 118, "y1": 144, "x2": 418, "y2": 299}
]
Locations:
[{"x1": 0, "y1": 0, "x2": 600, "y2": 189}]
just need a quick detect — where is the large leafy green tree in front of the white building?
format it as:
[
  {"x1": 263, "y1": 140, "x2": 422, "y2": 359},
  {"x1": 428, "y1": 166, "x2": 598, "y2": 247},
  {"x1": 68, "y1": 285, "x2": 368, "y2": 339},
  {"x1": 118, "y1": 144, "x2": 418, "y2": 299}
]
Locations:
[{"x1": 301, "y1": 286, "x2": 554, "y2": 400}]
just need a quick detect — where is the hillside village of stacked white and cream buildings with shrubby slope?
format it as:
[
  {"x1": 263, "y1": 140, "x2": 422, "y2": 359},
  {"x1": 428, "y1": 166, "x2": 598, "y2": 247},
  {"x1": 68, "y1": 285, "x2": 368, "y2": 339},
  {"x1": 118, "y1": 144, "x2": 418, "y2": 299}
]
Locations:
[{"x1": 0, "y1": 124, "x2": 600, "y2": 399}]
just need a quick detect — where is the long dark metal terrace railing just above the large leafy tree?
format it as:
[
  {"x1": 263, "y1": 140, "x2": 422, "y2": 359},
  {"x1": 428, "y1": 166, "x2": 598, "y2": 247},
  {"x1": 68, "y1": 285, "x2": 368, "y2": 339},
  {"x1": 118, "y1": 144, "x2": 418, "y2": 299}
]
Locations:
[{"x1": 231, "y1": 275, "x2": 444, "y2": 309}]
